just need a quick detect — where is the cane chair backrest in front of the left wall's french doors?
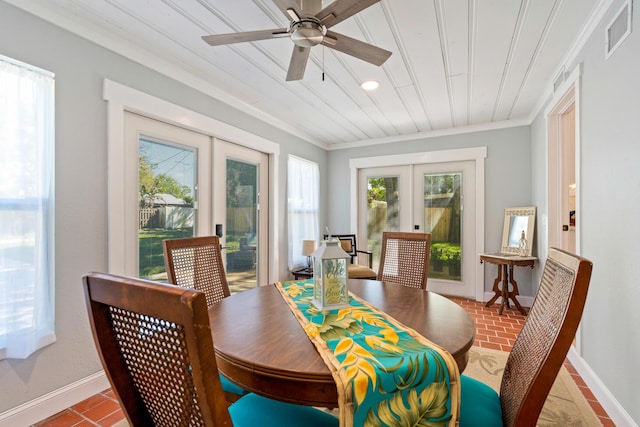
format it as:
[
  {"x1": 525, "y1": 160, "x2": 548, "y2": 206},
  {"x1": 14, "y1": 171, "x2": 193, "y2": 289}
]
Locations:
[{"x1": 162, "y1": 236, "x2": 231, "y2": 307}]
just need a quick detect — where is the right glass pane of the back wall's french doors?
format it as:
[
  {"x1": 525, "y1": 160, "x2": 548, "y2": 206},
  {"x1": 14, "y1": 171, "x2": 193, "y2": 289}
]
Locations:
[{"x1": 424, "y1": 173, "x2": 462, "y2": 281}]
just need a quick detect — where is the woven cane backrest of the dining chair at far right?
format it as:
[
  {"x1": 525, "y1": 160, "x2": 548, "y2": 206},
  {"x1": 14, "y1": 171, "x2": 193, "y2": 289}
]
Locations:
[{"x1": 500, "y1": 248, "x2": 593, "y2": 426}]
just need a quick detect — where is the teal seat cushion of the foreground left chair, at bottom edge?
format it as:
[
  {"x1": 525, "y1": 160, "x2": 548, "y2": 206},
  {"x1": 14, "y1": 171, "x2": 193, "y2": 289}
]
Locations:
[{"x1": 229, "y1": 393, "x2": 338, "y2": 427}]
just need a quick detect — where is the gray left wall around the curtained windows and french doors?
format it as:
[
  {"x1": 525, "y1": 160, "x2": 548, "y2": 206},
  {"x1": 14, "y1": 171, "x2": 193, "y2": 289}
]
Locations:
[{"x1": 0, "y1": 1, "x2": 326, "y2": 413}]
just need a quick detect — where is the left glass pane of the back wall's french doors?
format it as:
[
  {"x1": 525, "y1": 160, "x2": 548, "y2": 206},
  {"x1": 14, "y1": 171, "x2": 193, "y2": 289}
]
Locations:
[{"x1": 358, "y1": 176, "x2": 400, "y2": 269}]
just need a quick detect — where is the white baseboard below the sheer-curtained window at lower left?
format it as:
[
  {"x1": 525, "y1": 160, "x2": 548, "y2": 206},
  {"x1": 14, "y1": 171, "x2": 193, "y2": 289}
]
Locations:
[{"x1": 0, "y1": 371, "x2": 111, "y2": 427}]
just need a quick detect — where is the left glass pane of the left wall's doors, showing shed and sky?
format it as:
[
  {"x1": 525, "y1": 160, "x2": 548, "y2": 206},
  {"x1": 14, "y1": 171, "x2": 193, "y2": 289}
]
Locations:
[{"x1": 138, "y1": 139, "x2": 196, "y2": 282}]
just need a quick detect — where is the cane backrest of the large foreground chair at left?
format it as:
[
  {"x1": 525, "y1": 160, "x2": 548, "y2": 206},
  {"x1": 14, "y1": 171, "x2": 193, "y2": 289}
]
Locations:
[{"x1": 83, "y1": 273, "x2": 232, "y2": 426}]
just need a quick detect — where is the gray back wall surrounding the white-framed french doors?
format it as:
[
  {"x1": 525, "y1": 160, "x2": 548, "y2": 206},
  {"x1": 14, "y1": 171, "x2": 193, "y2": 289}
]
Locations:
[{"x1": 327, "y1": 126, "x2": 536, "y2": 295}]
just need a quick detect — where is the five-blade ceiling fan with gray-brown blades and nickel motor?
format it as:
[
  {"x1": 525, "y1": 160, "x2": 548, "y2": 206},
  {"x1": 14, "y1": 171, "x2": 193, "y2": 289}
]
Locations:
[{"x1": 202, "y1": 0, "x2": 391, "y2": 81}]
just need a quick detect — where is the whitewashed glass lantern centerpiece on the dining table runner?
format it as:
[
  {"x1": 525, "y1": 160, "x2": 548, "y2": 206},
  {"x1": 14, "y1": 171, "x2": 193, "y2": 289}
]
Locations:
[{"x1": 311, "y1": 239, "x2": 349, "y2": 311}]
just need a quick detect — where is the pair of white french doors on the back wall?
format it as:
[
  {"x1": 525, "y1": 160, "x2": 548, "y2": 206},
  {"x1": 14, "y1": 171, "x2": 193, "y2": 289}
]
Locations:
[{"x1": 358, "y1": 161, "x2": 476, "y2": 298}]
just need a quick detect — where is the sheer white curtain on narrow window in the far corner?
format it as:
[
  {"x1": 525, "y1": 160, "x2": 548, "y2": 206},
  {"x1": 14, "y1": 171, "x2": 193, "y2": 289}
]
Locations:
[{"x1": 287, "y1": 155, "x2": 320, "y2": 270}]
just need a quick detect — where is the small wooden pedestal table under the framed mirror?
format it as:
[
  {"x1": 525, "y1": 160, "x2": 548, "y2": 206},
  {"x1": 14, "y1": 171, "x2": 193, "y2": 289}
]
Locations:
[{"x1": 480, "y1": 254, "x2": 538, "y2": 315}]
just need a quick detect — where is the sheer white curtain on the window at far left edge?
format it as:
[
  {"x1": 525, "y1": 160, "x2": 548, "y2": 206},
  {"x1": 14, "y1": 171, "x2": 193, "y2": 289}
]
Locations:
[{"x1": 0, "y1": 56, "x2": 55, "y2": 359}]
